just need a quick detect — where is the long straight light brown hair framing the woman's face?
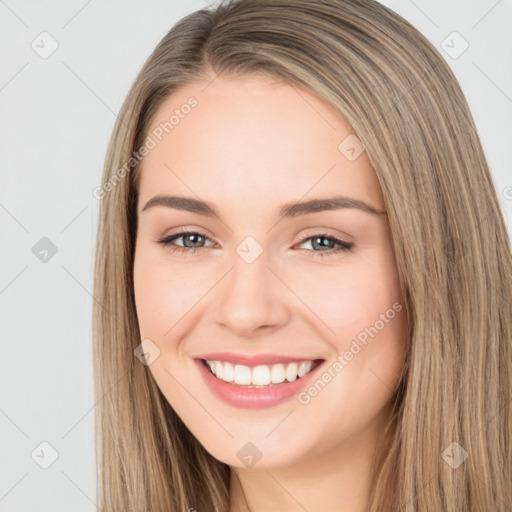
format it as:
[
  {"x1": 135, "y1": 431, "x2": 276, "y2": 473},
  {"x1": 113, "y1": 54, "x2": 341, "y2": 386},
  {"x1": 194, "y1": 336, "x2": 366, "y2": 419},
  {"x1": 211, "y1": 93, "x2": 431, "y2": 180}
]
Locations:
[{"x1": 93, "y1": 0, "x2": 512, "y2": 512}]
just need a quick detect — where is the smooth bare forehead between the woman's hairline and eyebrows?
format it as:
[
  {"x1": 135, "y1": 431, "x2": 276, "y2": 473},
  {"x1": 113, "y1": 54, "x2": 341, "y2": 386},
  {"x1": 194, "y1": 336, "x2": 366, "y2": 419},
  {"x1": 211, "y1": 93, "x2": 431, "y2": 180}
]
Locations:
[{"x1": 139, "y1": 76, "x2": 383, "y2": 214}]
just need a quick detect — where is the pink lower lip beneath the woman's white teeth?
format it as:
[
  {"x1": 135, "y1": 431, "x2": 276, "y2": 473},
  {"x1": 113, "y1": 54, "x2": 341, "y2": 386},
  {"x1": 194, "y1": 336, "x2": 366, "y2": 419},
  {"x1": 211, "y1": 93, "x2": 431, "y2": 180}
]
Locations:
[{"x1": 195, "y1": 359, "x2": 325, "y2": 409}]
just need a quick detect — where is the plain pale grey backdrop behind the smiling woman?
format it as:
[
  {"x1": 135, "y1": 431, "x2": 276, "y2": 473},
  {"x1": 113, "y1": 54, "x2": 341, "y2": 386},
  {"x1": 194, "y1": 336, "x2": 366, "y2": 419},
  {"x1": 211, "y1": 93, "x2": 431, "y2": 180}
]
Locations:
[{"x1": 0, "y1": 0, "x2": 512, "y2": 512}]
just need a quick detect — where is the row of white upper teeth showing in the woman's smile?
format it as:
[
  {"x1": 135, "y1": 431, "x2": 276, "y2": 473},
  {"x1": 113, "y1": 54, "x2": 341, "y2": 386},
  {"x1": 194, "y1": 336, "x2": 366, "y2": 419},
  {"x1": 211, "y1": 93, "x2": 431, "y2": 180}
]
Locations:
[{"x1": 206, "y1": 360, "x2": 314, "y2": 387}]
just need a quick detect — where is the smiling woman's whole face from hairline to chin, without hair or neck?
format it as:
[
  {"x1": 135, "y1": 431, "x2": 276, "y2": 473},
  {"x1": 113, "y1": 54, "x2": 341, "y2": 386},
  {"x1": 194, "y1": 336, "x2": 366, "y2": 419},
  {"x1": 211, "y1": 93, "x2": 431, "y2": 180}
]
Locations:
[{"x1": 134, "y1": 76, "x2": 405, "y2": 468}]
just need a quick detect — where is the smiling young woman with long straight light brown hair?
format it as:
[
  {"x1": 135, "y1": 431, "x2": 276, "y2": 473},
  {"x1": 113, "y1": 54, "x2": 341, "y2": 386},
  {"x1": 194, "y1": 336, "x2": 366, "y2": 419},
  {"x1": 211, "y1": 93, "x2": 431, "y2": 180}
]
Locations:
[{"x1": 94, "y1": 0, "x2": 512, "y2": 512}]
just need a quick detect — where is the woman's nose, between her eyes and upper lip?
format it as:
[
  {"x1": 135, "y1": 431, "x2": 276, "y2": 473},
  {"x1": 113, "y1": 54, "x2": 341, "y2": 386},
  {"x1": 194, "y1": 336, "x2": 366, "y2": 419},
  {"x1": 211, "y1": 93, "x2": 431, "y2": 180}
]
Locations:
[{"x1": 214, "y1": 252, "x2": 290, "y2": 337}]
